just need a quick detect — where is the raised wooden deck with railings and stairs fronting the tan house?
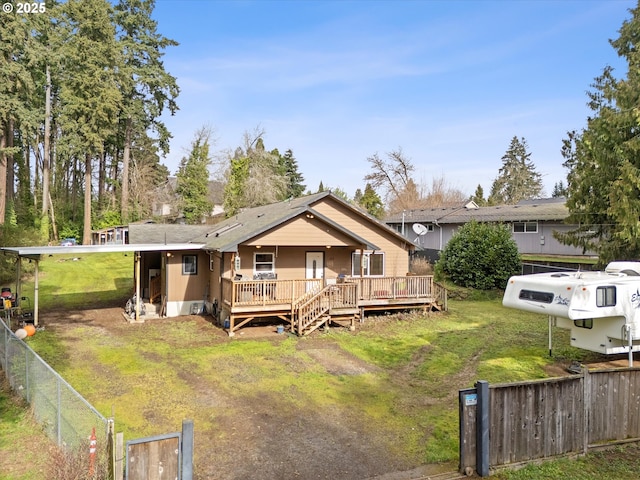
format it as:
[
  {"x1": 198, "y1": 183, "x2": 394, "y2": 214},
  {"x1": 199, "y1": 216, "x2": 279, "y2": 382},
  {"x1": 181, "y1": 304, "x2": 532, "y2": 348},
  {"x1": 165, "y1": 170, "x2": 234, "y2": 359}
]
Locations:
[{"x1": 222, "y1": 275, "x2": 447, "y2": 336}]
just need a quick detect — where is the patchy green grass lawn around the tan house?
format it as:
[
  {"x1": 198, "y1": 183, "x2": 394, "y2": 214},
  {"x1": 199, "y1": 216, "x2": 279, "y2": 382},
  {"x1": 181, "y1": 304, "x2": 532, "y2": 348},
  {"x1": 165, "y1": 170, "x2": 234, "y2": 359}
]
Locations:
[{"x1": 0, "y1": 255, "x2": 638, "y2": 480}]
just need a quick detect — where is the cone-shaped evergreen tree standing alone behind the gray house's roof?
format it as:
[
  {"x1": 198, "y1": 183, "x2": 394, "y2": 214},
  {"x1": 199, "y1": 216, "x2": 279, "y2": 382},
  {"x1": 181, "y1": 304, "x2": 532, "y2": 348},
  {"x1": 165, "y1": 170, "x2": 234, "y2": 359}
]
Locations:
[{"x1": 488, "y1": 136, "x2": 542, "y2": 205}]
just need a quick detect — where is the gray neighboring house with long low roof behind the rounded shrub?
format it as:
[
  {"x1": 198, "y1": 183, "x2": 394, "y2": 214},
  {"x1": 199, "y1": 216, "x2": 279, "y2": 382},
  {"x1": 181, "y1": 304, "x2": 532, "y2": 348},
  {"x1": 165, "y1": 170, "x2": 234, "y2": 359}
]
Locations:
[{"x1": 385, "y1": 198, "x2": 593, "y2": 255}]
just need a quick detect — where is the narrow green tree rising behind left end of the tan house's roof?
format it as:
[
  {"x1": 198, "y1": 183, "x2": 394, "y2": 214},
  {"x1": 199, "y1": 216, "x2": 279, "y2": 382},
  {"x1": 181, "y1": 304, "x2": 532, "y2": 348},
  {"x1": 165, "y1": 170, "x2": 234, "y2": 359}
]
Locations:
[{"x1": 176, "y1": 128, "x2": 213, "y2": 224}]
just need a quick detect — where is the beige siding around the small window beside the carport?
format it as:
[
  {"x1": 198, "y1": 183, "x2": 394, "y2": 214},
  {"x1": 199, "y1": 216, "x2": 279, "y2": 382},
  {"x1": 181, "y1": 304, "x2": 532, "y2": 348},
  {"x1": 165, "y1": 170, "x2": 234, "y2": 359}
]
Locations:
[{"x1": 167, "y1": 250, "x2": 209, "y2": 302}]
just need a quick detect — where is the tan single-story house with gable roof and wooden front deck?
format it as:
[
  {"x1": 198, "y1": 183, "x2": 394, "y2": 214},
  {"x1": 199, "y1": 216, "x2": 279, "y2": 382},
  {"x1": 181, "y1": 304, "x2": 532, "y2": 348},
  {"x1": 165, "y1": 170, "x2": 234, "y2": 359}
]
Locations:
[{"x1": 129, "y1": 192, "x2": 446, "y2": 335}]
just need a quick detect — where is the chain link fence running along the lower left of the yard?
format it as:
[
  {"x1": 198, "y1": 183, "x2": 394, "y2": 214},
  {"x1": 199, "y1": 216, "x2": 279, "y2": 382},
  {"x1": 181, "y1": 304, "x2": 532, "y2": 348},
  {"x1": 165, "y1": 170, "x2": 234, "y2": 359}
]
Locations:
[{"x1": 0, "y1": 319, "x2": 113, "y2": 478}]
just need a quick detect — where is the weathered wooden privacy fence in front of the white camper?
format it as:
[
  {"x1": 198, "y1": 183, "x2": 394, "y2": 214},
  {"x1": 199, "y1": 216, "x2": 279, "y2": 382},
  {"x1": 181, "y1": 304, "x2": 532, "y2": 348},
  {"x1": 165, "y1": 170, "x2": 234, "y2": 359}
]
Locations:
[{"x1": 459, "y1": 368, "x2": 640, "y2": 476}]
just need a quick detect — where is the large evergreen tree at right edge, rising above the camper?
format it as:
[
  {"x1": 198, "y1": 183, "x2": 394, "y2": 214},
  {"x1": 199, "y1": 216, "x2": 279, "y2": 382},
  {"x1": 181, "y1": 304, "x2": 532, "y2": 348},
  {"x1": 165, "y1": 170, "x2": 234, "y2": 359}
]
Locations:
[{"x1": 557, "y1": 3, "x2": 640, "y2": 263}]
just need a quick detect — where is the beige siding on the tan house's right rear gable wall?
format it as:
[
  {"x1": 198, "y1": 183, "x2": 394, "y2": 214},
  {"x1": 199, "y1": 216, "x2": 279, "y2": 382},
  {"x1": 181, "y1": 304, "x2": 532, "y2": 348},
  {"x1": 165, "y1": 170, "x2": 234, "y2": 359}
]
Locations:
[{"x1": 313, "y1": 197, "x2": 409, "y2": 276}]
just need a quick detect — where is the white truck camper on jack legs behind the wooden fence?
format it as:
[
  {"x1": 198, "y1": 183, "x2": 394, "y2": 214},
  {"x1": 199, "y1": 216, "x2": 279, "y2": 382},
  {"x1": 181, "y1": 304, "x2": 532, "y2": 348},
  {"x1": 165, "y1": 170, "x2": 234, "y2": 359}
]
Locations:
[{"x1": 502, "y1": 262, "x2": 640, "y2": 366}]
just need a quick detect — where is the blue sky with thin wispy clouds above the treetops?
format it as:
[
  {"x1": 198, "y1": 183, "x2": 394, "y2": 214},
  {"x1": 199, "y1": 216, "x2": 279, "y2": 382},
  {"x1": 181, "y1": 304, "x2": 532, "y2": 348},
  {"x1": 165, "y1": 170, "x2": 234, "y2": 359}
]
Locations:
[{"x1": 154, "y1": 0, "x2": 635, "y2": 201}]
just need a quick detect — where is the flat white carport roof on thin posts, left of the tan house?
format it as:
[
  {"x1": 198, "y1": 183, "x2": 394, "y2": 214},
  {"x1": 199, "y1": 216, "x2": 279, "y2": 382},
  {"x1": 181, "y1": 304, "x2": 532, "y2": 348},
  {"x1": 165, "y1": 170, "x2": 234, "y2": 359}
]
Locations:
[{"x1": 0, "y1": 243, "x2": 202, "y2": 327}]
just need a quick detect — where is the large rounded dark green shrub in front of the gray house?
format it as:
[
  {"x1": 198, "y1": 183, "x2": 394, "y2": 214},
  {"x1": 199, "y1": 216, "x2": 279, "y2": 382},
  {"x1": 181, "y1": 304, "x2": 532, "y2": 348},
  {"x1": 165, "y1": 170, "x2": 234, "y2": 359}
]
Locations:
[{"x1": 436, "y1": 221, "x2": 520, "y2": 290}]
